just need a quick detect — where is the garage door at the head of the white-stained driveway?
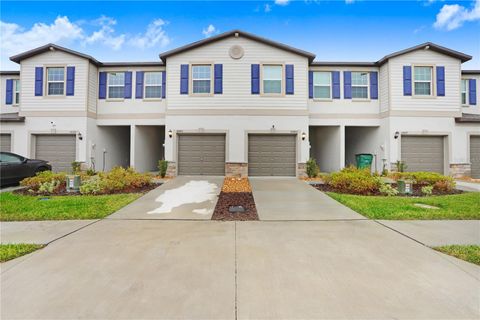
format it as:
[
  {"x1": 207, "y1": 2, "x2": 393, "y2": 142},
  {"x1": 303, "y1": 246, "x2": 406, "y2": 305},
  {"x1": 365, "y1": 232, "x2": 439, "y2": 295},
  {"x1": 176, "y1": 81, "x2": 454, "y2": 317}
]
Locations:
[{"x1": 178, "y1": 134, "x2": 225, "y2": 176}]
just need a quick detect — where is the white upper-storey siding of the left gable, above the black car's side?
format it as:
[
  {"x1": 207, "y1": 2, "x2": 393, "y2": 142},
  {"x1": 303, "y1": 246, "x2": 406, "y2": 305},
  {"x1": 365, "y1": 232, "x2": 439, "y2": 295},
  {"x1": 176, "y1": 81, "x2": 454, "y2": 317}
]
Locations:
[{"x1": 21, "y1": 51, "x2": 89, "y2": 112}]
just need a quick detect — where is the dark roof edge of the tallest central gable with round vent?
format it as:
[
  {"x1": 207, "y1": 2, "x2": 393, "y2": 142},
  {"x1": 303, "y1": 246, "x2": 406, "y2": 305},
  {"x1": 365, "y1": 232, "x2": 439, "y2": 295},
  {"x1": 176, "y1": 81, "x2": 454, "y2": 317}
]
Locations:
[{"x1": 159, "y1": 30, "x2": 315, "y2": 62}]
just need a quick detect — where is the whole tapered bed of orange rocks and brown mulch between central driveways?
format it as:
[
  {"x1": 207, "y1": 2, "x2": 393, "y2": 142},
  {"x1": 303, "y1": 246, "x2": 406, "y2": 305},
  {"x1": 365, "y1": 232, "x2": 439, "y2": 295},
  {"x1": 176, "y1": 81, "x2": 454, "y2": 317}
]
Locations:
[{"x1": 212, "y1": 178, "x2": 258, "y2": 221}]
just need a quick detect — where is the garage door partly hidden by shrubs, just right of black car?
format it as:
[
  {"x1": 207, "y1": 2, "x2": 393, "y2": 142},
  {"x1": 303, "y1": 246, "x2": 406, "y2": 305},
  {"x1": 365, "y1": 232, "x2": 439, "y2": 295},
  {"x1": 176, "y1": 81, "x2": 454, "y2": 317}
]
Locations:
[{"x1": 35, "y1": 135, "x2": 76, "y2": 172}]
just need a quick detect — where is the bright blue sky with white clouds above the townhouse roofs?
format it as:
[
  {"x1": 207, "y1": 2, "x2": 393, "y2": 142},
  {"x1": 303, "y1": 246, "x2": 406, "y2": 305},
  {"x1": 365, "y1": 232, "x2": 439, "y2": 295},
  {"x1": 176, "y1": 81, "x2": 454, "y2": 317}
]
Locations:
[{"x1": 0, "y1": 0, "x2": 480, "y2": 70}]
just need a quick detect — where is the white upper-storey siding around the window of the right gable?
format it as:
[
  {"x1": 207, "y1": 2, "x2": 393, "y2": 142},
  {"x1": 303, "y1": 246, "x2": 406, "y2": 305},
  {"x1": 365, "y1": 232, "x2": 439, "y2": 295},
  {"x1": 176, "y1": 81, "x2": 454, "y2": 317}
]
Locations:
[{"x1": 389, "y1": 50, "x2": 460, "y2": 111}]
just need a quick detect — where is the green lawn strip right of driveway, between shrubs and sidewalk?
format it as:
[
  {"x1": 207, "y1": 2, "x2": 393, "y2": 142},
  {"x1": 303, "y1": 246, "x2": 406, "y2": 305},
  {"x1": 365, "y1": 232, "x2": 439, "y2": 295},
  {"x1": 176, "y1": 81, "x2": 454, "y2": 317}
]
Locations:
[{"x1": 327, "y1": 192, "x2": 480, "y2": 220}]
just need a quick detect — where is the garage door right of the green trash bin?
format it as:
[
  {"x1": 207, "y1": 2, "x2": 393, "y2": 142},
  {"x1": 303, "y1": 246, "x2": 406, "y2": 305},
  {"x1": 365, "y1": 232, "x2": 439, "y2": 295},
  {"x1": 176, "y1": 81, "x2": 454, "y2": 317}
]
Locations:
[{"x1": 401, "y1": 136, "x2": 445, "y2": 174}]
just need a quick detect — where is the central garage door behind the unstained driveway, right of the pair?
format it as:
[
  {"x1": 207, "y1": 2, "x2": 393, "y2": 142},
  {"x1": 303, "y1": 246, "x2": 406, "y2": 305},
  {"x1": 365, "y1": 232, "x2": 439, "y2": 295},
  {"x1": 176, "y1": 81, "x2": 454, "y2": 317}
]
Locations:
[{"x1": 248, "y1": 134, "x2": 297, "y2": 176}]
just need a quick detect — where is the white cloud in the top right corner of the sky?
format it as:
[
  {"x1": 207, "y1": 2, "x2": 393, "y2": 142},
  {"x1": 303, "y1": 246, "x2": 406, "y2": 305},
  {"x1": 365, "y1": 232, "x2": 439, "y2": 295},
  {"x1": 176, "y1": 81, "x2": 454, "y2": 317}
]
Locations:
[{"x1": 433, "y1": 0, "x2": 480, "y2": 31}]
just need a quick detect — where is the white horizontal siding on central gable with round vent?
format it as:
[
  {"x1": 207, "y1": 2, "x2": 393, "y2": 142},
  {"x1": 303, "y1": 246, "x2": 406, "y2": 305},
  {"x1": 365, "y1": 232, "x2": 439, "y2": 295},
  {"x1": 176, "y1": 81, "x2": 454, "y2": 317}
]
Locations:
[{"x1": 167, "y1": 36, "x2": 308, "y2": 109}]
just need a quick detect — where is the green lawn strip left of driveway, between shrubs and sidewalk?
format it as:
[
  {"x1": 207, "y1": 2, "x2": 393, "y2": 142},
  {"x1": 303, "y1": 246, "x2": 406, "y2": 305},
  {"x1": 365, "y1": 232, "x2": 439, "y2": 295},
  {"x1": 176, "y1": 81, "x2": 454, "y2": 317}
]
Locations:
[{"x1": 0, "y1": 192, "x2": 142, "y2": 221}]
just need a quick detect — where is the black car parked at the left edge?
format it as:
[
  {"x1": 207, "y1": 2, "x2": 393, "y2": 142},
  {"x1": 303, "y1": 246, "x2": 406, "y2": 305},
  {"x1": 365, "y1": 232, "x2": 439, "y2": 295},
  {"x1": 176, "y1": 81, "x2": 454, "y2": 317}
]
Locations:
[{"x1": 0, "y1": 152, "x2": 52, "y2": 186}]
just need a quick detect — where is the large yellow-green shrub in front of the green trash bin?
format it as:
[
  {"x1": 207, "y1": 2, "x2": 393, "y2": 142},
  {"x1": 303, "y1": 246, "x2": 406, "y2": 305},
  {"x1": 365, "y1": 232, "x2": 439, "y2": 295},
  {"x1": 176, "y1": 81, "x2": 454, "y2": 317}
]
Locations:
[{"x1": 326, "y1": 166, "x2": 381, "y2": 194}]
